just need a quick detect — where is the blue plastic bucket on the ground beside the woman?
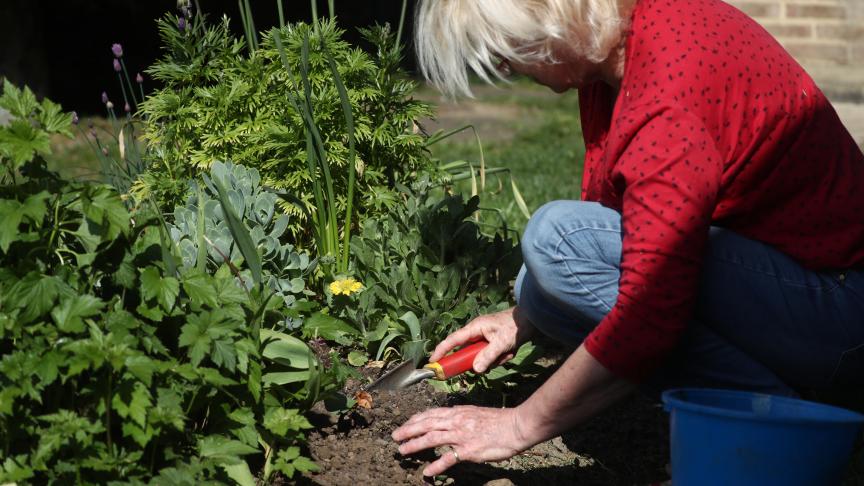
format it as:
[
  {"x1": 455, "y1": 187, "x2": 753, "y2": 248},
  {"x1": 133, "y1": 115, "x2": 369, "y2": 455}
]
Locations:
[{"x1": 663, "y1": 389, "x2": 864, "y2": 486}]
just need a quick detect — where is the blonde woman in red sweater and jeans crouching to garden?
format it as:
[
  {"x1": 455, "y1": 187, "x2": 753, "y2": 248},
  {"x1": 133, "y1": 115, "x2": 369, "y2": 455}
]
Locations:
[{"x1": 393, "y1": 0, "x2": 864, "y2": 475}]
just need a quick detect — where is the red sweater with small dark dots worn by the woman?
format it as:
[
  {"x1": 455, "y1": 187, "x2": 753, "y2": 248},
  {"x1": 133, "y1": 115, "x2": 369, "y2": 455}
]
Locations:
[{"x1": 579, "y1": 0, "x2": 864, "y2": 381}]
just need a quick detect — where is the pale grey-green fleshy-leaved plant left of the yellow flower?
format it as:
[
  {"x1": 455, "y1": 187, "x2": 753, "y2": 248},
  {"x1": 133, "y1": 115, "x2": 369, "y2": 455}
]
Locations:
[{"x1": 168, "y1": 162, "x2": 316, "y2": 329}]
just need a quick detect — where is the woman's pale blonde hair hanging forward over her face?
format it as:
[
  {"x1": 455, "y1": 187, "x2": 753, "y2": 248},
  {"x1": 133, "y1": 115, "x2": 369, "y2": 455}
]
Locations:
[{"x1": 414, "y1": 0, "x2": 625, "y2": 97}]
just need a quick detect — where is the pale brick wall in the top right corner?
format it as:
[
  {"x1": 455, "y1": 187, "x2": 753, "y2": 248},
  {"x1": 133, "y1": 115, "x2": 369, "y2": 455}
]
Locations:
[{"x1": 727, "y1": 0, "x2": 864, "y2": 67}]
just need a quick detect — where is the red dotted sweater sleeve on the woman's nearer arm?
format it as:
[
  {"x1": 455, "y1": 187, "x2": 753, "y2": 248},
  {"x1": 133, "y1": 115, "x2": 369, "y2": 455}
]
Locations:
[{"x1": 585, "y1": 107, "x2": 723, "y2": 382}]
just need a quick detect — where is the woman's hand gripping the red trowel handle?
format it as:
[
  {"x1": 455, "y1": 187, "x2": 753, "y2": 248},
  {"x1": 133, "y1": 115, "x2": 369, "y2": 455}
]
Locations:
[{"x1": 429, "y1": 307, "x2": 534, "y2": 373}]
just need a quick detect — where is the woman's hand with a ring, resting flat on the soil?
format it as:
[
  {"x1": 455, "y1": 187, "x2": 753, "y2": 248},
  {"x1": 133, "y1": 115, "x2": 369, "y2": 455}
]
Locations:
[{"x1": 392, "y1": 406, "x2": 533, "y2": 476}]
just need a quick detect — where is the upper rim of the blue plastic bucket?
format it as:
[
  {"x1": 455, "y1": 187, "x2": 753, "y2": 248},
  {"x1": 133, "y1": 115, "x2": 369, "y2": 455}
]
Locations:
[{"x1": 661, "y1": 388, "x2": 864, "y2": 425}]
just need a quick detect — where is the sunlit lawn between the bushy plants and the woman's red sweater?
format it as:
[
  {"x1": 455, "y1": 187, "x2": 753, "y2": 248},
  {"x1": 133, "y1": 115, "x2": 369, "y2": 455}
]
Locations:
[{"x1": 420, "y1": 81, "x2": 585, "y2": 232}]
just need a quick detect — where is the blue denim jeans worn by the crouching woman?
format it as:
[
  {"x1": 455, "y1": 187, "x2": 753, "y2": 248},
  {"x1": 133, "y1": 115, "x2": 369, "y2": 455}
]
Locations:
[{"x1": 515, "y1": 201, "x2": 864, "y2": 396}]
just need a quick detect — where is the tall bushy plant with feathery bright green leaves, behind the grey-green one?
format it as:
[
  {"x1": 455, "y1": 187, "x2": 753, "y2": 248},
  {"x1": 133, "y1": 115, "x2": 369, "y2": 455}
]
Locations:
[{"x1": 140, "y1": 16, "x2": 431, "y2": 246}]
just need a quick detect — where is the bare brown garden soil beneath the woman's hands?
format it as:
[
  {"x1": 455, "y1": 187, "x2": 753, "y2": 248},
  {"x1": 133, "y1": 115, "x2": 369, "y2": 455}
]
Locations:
[{"x1": 302, "y1": 344, "x2": 669, "y2": 486}]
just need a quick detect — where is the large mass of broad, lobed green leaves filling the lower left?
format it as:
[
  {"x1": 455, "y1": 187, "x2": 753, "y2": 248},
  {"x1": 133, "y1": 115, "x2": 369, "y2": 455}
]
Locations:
[{"x1": 0, "y1": 86, "x2": 334, "y2": 484}]
